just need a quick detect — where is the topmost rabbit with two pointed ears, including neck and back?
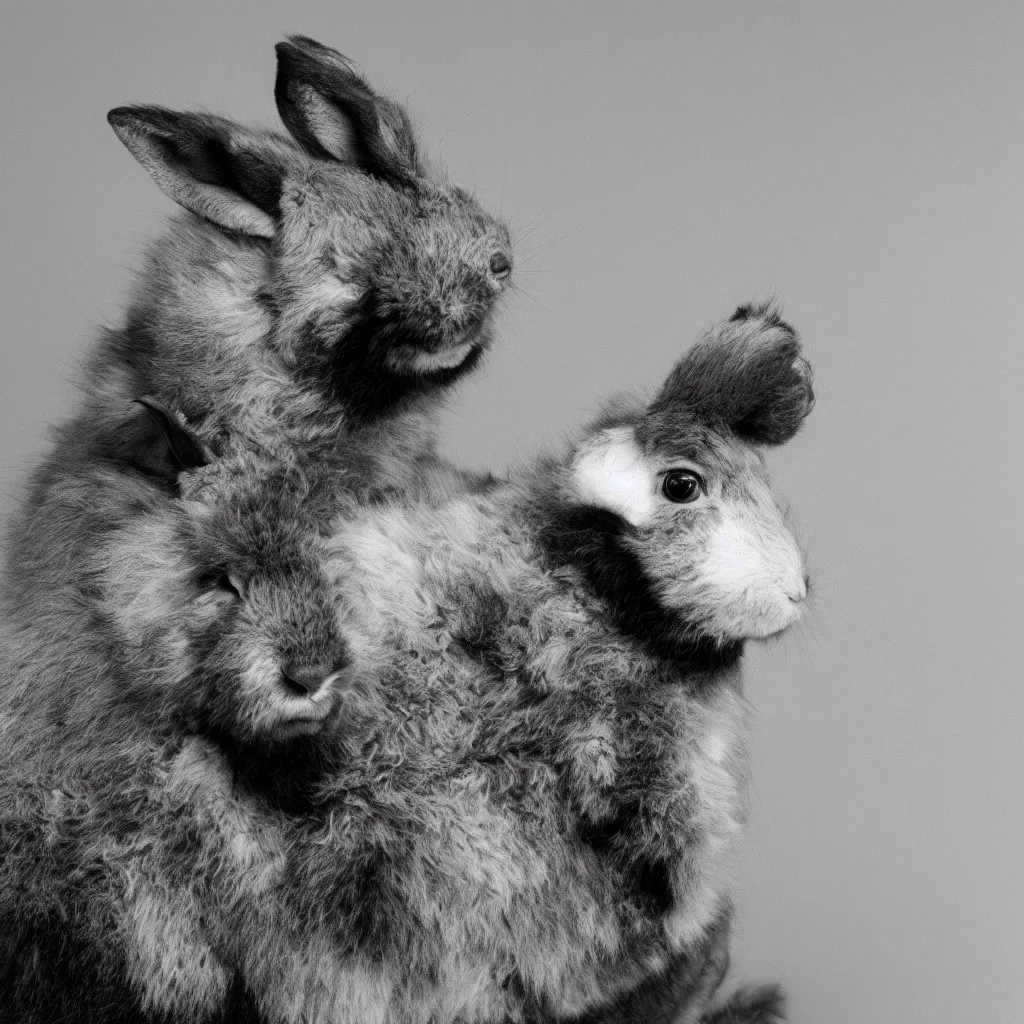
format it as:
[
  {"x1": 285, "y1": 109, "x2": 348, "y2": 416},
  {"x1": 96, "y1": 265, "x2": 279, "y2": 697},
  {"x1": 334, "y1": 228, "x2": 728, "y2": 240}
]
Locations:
[{"x1": 0, "y1": 37, "x2": 511, "y2": 745}]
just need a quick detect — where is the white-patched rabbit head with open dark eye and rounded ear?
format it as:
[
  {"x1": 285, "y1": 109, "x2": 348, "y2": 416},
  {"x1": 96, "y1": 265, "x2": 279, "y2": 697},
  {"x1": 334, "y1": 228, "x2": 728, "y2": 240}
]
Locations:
[{"x1": 569, "y1": 306, "x2": 814, "y2": 644}]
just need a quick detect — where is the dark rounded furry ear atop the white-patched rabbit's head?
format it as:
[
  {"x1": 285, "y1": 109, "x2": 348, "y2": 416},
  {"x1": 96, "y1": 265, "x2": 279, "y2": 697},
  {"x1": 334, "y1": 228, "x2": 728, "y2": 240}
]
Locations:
[{"x1": 650, "y1": 303, "x2": 814, "y2": 444}]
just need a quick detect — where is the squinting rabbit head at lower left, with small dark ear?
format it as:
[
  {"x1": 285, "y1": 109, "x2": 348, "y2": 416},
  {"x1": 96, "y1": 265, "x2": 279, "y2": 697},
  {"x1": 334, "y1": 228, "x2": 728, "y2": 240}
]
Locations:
[{"x1": 97, "y1": 400, "x2": 348, "y2": 749}]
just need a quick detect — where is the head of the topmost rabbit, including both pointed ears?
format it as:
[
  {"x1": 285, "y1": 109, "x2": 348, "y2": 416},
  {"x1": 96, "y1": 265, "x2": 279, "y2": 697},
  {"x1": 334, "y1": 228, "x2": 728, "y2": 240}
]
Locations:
[{"x1": 109, "y1": 36, "x2": 512, "y2": 419}]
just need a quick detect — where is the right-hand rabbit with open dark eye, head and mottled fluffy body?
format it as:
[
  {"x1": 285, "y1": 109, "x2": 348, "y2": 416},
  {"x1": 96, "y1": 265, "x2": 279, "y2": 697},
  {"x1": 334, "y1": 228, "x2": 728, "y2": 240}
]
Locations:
[{"x1": 278, "y1": 305, "x2": 813, "y2": 1020}]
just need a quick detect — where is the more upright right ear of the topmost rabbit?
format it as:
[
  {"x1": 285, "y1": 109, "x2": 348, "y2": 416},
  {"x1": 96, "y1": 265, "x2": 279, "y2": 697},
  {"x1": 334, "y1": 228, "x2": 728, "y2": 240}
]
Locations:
[{"x1": 274, "y1": 36, "x2": 418, "y2": 180}]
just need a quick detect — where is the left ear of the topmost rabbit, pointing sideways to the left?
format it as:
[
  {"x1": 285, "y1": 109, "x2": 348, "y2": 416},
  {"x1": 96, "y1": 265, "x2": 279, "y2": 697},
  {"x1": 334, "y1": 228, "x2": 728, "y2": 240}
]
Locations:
[{"x1": 106, "y1": 106, "x2": 301, "y2": 239}]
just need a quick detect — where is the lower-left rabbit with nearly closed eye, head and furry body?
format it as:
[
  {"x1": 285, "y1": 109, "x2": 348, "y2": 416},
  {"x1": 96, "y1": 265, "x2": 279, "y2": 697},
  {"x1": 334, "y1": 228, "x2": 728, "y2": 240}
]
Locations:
[{"x1": 0, "y1": 399, "x2": 349, "y2": 1024}]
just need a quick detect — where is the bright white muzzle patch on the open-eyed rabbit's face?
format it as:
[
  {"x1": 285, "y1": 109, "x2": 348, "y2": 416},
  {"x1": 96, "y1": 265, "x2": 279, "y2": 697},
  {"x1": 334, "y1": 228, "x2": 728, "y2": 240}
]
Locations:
[{"x1": 698, "y1": 512, "x2": 807, "y2": 640}]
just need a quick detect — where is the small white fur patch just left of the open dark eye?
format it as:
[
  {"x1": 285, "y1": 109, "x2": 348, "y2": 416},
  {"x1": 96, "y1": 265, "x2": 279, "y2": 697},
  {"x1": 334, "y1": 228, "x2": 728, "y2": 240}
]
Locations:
[{"x1": 572, "y1": 427, "x2": 657, "y2": 526}]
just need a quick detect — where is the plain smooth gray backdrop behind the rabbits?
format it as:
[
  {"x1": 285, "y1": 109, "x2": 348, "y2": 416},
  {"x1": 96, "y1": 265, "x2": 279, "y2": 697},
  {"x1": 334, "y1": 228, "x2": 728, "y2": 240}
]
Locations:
[{"x1": 0, "y1": 0, "x2": 1024, "y2": 1024}]
